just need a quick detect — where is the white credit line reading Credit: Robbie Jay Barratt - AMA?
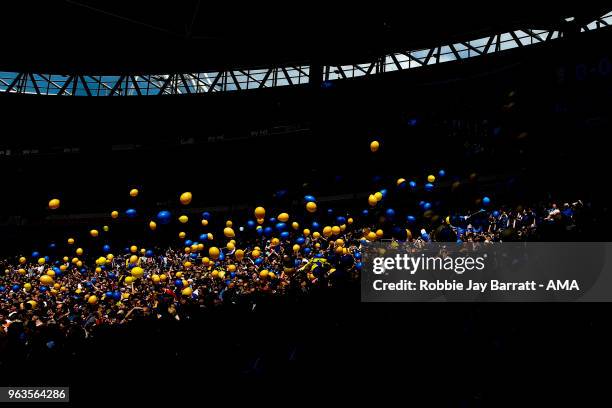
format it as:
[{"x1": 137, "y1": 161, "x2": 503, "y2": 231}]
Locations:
[{"x1": 373, "y1": 279, "x2": 580, "y2": 292}]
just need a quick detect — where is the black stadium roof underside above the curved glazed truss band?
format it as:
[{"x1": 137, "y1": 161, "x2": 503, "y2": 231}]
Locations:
[{"x1": 0, "y1": 0, "x2": 609, "y2": 74}]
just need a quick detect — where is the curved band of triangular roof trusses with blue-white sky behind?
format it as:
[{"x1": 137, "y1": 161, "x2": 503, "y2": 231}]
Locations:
[{"x1": 0, "y1": 11, "x2": 612, "y2": 96}]
